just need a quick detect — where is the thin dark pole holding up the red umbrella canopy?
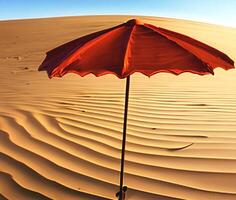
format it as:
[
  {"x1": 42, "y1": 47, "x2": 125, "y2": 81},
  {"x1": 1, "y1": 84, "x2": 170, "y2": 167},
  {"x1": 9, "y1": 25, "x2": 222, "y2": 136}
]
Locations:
[{"x1": 119, "y1": 76, "x2": 130, "y2": 200}]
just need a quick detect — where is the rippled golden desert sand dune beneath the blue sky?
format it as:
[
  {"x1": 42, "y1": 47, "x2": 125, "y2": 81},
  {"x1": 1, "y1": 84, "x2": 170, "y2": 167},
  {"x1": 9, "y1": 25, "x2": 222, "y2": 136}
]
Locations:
[{"x1": 0, "y1": 16, "x2": 236, "y2": 200}]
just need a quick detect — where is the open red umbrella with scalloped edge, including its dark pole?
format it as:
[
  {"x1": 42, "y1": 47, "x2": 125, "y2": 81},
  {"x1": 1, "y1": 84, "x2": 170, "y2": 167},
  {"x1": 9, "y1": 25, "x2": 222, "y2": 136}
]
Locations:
[{"x1": 39, "y1": 19, "x2": 234, "y2": 200}]
